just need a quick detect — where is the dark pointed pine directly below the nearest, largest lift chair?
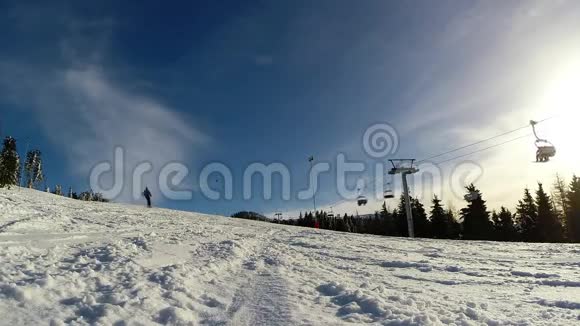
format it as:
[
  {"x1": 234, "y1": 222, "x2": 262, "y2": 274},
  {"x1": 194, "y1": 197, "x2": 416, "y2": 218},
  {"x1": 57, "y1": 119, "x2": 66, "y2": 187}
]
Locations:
[{"x1": 536, "y1": 183, "x2": 563, "y2": 242}]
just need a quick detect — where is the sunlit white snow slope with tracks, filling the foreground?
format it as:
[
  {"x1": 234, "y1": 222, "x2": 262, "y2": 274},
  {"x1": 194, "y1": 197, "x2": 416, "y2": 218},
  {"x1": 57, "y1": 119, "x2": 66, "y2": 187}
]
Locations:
[{"x1": 0, "y1": 189, "x2": 580, "y2": 325}]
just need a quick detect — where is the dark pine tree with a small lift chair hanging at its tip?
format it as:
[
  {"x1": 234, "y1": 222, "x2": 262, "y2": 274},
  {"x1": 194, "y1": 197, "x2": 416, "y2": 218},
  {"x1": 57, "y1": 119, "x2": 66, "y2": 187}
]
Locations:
[{"x1": 461, "y1": 184, "x2": 492, "y2": 240}]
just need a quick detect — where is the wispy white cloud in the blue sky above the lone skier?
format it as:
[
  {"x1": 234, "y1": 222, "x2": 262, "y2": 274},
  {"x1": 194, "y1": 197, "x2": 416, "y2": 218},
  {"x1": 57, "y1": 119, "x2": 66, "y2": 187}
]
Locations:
[{"x1": 59, "y1": 68, "x2": 209, "y2": 200}]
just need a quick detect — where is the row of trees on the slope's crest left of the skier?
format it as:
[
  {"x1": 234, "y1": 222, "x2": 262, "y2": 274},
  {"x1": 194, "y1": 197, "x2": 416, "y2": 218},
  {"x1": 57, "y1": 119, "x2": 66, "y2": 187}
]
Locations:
[{"x1": 0, "y1": 136, "x2": 108, "y2": 202}]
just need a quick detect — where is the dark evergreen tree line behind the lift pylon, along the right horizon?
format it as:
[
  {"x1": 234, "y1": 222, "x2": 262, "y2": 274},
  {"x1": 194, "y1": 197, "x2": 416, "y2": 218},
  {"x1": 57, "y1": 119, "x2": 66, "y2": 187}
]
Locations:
[{"x1": 232, "y1": 176, "x2": 580, "y2": 242}]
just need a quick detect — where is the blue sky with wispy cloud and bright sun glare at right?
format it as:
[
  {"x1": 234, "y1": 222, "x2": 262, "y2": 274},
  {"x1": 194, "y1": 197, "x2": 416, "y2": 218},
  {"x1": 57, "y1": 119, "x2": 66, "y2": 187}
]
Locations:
[{"x1": 0, "y1": 0, "x2": 580, "y2": 216}]
